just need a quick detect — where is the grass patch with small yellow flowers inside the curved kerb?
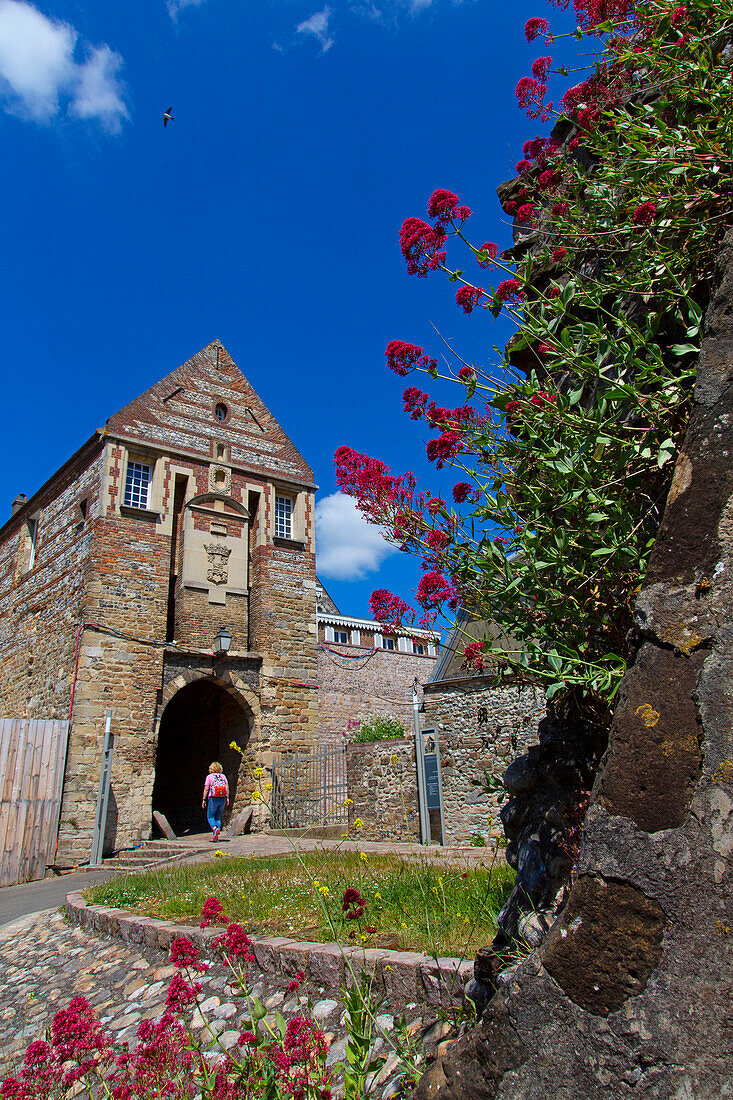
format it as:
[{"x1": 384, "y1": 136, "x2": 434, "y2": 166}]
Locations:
[{"x1": 85, "y1": 851, "x2": 514, "y2": 955}]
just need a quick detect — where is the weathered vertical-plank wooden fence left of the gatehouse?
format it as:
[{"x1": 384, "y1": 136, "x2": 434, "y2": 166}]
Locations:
[{"x1": 0, "y1": 718, "x2": 68, "y2": 887}]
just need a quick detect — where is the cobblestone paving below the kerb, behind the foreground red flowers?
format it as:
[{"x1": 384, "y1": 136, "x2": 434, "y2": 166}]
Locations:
[{"x1": 0, "y1": 910, "x2": 455, "y2": 1086}]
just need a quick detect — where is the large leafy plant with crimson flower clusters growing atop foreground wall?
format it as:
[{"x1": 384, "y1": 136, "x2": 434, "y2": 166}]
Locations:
[{"x1": 336, "y1": 0, "x2": 733, "y2": 714}]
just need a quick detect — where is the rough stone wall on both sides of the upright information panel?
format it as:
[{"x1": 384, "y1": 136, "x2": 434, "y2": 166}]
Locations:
[{"x1": 347, "y1": 679, "x2": 545, "y2": 844}]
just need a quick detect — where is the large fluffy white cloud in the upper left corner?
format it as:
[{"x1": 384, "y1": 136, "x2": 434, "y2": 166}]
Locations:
[{"x1": 0, "y1": 0, "x2": 128, "y2": 131}]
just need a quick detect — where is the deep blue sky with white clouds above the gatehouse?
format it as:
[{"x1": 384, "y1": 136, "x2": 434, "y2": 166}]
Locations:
[{"x1": 0, "y1": 0, "x2": 572, "y2": 615}]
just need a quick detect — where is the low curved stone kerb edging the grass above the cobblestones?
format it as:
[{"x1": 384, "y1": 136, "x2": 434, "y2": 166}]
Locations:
[{"x1": 66, "y1": 893, "x2": 473, "y2": 1008}]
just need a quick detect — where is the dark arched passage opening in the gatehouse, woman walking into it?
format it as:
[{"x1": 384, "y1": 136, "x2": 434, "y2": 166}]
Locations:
[{"x1": 153, "y1": 679, "x2": 250, "y2": 836}]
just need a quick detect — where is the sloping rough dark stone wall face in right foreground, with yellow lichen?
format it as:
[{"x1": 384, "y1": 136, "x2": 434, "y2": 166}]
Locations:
[{"x1": 418, "y1": 227, "x2": 733, "y2": 1100}]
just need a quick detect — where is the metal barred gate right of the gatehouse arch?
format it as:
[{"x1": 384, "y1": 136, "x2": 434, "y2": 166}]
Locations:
[{"x1": 272, "y1": 747, "x2": 349, "y2": 828}]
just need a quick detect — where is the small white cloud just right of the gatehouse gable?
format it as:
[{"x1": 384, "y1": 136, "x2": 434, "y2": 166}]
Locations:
[{"x1": 316, "y1": 493, "x2": 396, "y2": 581}]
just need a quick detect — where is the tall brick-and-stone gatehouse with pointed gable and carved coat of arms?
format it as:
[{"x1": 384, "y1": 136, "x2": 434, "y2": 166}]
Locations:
[{"x1": 0, "y1": 341, "x2": 318, "y2": 862}]
